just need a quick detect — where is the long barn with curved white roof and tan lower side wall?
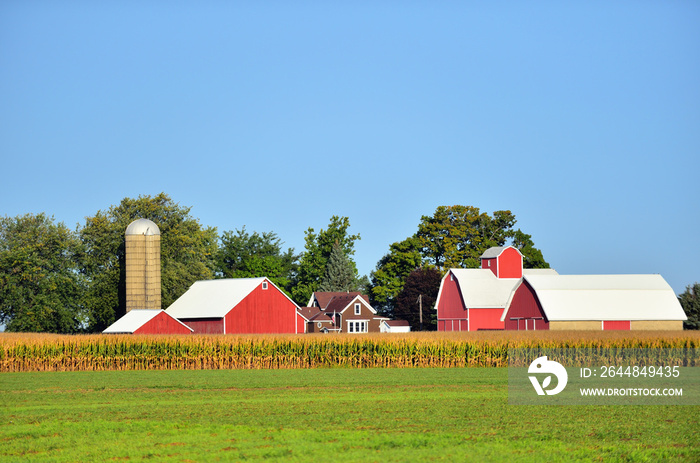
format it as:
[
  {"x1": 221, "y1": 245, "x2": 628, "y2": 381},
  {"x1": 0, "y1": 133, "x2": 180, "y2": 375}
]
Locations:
[{"x1": 501, "y1": 275, "x2": 687, "y2": 331}]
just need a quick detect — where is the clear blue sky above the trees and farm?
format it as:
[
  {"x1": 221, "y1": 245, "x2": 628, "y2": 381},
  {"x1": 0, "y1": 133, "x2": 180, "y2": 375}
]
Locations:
[{"x1": 0, "y1": 1, "x2": 700, "y2": 293}]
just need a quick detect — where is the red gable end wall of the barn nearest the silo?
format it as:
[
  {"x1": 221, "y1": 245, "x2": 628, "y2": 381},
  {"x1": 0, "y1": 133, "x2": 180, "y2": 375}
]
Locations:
[{"x1": 225, "y1": 284, "x2": 297, "y2": 334}]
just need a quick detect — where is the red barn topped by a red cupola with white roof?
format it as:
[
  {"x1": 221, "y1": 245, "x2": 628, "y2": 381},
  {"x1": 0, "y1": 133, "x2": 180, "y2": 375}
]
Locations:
[{"x1": 435, "y1": 246, "x2": 556, "y2": 331}]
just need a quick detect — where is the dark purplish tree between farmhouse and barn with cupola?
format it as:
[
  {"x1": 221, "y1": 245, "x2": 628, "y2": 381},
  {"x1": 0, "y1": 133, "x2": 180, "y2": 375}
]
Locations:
[{"x1": 394, "y1": 268, "x2": 442, "y2": 331}]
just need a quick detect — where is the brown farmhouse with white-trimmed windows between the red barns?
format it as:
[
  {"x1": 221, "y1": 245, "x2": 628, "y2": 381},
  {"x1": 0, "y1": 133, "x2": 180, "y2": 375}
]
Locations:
[{"x1": 300, "y1": 292, "x2": 389, "y2": 333}]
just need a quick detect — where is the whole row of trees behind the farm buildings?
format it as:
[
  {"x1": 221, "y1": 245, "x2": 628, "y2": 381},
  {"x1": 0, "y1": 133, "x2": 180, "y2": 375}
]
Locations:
[{"x1": 0, "y1": 193, "x2": 696, "y2": 333}]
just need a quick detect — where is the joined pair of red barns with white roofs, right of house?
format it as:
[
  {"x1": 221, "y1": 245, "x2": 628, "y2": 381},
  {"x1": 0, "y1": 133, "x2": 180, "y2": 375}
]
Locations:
[{"x1": 435, "y1": 246, "x2": 686, "y2": 331}]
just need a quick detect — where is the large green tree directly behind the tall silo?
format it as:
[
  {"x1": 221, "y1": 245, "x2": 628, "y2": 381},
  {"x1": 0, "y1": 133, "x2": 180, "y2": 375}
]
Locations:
[{"x1": 80, "y1": 193, "x2": 218, "y2": 331}]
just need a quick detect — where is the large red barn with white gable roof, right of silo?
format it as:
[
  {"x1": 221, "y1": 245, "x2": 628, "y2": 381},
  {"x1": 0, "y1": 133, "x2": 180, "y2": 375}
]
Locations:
[{"x1": 166, "y1": 278, "x2": 306, "y2": 334}]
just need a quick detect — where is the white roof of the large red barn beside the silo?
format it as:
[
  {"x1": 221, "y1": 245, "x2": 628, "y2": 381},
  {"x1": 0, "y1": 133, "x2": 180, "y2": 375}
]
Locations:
[{"x1": 166, "y1": 277, "x2": 297, "y2": 319}]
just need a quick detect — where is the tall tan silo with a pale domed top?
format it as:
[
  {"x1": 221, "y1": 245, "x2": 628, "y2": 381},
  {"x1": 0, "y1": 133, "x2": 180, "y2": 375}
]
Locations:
[{"x1": 126, "y1": 219, "x2": 160, "y2": 312}]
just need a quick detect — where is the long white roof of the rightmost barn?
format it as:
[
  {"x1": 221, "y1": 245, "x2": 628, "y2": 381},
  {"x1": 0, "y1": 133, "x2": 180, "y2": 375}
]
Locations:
[{"x1": 501, "y1": 274, "x2": 687, "y2": 321}]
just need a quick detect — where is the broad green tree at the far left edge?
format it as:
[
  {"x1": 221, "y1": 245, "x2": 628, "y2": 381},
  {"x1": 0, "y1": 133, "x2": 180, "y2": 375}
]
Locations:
[{"x1": 0, "y1": 213, "x2": 83, "y2": 333}]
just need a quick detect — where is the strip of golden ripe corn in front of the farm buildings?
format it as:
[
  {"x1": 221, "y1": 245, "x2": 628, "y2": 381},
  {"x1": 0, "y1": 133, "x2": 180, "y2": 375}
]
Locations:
[{"x1": 0, "y1": 331, "x2": 700, "y2": 372}]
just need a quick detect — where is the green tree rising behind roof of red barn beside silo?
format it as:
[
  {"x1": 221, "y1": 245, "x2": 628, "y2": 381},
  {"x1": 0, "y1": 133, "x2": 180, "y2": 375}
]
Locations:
[{"x1": 217, "y1": 227, "x2": 298, "y2": 291}]
